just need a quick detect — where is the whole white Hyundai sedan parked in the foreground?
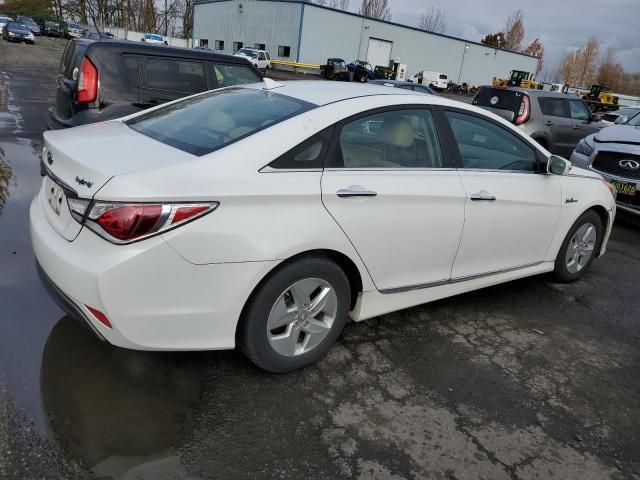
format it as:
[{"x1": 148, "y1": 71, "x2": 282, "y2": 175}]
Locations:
[{"x1": 30, "y1": 79, "x2": 615, "y2": 372}]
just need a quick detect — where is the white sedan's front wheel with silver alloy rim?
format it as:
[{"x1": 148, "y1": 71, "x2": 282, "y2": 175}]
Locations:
[{"x1": 553, "y1": 210, "x2": 603, "y2": 283}]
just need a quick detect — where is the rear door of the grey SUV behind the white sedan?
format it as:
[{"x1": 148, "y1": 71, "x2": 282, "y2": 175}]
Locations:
[{"x1": 538, "y1": 97, "x2": 577, "y2": 157}]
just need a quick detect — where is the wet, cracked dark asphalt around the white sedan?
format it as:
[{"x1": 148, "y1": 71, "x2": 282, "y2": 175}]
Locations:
[{"x1": 0, "y1": 40, "x2": 640, "y2": 479}]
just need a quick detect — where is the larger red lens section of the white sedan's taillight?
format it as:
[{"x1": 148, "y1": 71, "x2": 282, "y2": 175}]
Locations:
[{"x1": 96, "y1": 205, "x2": 162, "y2": 241}]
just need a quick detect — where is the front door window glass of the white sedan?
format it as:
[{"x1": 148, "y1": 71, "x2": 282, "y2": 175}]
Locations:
[{"x1": 445, "y1": 112, "x2": 536, "y2": 172}]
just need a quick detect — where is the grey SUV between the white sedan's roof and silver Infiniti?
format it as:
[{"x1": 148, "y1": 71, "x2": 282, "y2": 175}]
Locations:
[{"x1": 473, "y1": 86, "x2": 607, "y2": 157}]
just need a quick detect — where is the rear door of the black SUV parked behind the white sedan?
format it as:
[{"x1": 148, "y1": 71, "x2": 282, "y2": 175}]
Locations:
[{"x1": 138, "y1": 57, "x2": 208, "y2": 108}]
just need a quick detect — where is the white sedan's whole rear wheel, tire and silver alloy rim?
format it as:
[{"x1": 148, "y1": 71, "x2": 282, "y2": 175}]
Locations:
[{"x1": 238, "y1": 257, "x2": 351, "y2": 373}]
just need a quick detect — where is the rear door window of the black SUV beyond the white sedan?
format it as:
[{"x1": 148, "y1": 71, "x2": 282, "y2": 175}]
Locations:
[{"x1": 144, "y1": 58, "x2": 207, "y2": 93}]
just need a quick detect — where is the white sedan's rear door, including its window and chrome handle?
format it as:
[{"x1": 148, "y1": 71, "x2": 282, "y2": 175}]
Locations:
[{"x1": 322, "y1": 109, "x2": 465, "y2": 292}]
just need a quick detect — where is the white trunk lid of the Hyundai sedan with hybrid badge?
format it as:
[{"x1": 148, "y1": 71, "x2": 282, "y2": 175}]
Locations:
[{"x1": 40, "y1": 120, "x2": 196, "y2": 241}]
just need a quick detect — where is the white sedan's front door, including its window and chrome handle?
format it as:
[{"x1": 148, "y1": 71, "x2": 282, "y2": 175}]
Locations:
[{"x1": 445, "y1": 111, "x2": 561, "y2": 280}]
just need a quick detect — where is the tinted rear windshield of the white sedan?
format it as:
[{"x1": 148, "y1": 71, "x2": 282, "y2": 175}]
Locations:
[{"x1": 125, "y1": 87, "x2": 314, "y2": 155}]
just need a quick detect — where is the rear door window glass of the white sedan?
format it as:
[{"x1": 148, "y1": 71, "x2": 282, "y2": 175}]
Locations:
[{"x1": 329, "y1": 109, "x2": 443, "y2": 169}]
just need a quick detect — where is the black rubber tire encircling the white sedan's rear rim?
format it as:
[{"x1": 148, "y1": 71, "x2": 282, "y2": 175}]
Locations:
[{"x1": 236, "y1": 256, "x2": 351, "y2": 373}]
